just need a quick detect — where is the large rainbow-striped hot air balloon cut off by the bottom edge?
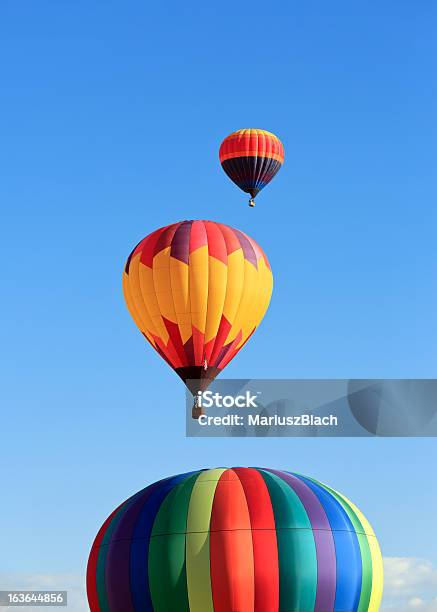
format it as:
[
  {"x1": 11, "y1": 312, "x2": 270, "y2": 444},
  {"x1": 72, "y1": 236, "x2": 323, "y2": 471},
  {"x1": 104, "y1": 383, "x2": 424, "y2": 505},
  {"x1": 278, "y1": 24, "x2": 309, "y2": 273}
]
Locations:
[{"x1": 87, "y1": 468, "x2": 383, "y2": 612}]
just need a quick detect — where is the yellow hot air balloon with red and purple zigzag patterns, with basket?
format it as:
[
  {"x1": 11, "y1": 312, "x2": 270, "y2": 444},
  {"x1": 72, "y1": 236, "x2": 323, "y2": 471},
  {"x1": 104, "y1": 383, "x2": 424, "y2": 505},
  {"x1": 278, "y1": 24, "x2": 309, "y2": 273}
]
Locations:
[{"x1": 123, "y1": 221, "x2": 273, "y2": 417}]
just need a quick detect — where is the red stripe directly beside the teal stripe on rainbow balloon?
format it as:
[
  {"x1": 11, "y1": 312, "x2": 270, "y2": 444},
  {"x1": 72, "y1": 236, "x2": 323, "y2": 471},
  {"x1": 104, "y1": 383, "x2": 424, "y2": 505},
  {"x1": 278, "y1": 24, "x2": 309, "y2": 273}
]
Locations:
[{"x1": 234, "y1": 468, "x2": 279, "y2": 612}]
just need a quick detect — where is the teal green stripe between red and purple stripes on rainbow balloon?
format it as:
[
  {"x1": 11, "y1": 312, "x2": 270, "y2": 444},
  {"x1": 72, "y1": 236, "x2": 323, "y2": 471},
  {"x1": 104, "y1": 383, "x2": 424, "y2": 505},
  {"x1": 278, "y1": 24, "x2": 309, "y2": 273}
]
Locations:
[{"x1": 258, "y1": 470, "x2": 317, "y2": 612}]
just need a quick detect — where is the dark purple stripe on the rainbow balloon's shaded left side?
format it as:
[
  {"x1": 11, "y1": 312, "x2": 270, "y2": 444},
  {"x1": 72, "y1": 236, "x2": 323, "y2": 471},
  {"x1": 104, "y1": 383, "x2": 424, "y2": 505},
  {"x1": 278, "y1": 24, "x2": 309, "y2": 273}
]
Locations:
[{"x1": 105, "y1": 479, "x2": 167, "y2": 612}]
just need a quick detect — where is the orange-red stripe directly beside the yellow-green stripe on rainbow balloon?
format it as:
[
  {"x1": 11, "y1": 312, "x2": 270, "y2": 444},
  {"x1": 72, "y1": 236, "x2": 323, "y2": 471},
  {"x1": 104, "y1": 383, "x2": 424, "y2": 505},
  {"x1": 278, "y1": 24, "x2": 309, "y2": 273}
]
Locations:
[{"x1": 210, "y1": 470, "x2": 255, "y2": 612}]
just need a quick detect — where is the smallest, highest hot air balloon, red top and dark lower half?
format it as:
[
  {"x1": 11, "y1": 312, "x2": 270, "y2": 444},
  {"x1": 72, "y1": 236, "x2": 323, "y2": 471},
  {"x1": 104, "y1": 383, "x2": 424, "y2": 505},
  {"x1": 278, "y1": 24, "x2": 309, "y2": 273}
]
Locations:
[{"x1": 219, "y1": 129, "x2": 284, "y2": 206}]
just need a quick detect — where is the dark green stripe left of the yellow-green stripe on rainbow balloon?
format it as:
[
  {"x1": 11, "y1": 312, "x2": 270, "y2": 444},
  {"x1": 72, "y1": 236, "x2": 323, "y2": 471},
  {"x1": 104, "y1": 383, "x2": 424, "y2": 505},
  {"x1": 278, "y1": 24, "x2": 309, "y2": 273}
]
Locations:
[{"x1": 149, "y1": 472, "x2": 199, "y2": 612}]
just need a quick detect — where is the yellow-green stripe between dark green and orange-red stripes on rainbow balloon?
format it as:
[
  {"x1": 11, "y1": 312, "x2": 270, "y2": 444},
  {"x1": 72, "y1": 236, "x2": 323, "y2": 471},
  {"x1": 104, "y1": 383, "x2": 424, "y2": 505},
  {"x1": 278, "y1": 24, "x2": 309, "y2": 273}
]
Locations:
[{"x1": 185, "y1": 469, "x2": 226, "y2": 612}]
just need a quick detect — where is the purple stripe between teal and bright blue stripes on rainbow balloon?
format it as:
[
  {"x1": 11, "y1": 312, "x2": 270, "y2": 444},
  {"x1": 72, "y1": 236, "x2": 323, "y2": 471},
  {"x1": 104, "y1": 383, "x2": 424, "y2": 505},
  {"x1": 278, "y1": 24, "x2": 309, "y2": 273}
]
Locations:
[{"x1": 268, "y1": 470, "x2": 337, "y2": 612}]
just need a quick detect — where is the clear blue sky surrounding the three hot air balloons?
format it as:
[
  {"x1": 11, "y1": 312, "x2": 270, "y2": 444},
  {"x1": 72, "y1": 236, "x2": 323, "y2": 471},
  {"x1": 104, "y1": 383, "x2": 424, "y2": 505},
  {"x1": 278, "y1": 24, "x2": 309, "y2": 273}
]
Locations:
[{"x1": 0, "y1": 0, "x2": 437, "y2": 608}]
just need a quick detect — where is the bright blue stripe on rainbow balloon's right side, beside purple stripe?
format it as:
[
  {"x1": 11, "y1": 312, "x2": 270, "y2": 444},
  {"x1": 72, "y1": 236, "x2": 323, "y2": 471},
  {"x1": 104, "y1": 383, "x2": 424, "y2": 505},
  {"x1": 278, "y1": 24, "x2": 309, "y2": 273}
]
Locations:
[{"x1": 293, "y1": 474, "x2": 363, "y2": 611}]
